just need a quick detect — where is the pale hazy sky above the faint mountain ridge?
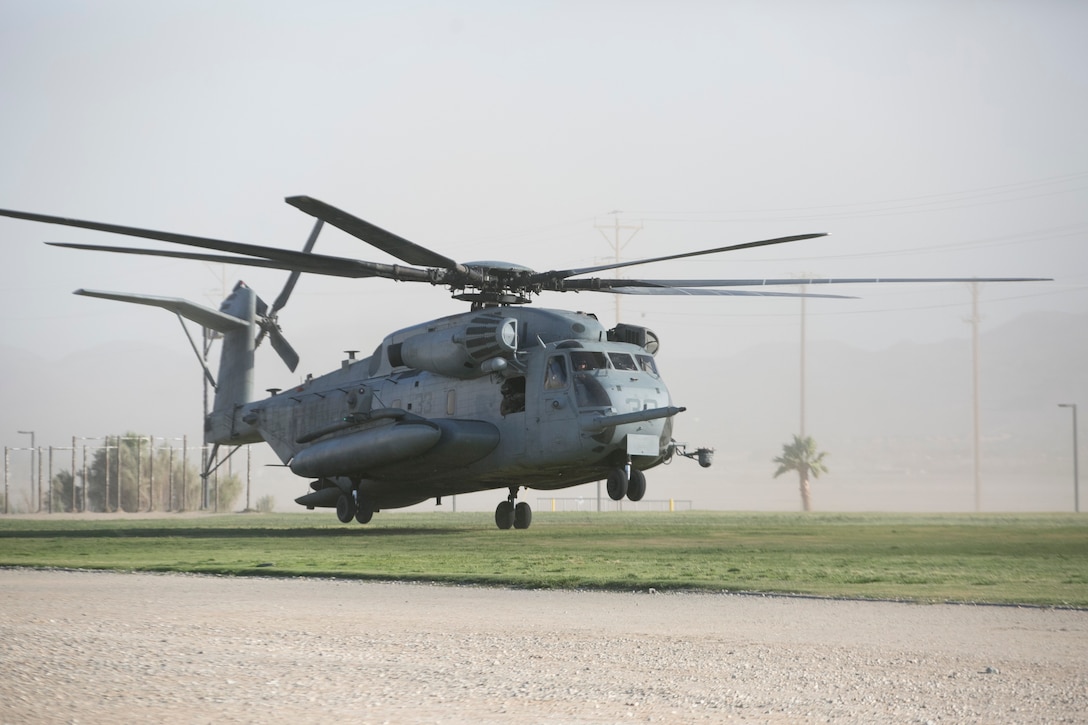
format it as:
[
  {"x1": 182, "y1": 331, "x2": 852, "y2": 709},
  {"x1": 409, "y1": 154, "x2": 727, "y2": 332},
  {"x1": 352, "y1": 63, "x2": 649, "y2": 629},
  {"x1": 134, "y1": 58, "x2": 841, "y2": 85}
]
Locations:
[{"x1": 0, "y1": 0, "x2": 1088, "y2": 507}]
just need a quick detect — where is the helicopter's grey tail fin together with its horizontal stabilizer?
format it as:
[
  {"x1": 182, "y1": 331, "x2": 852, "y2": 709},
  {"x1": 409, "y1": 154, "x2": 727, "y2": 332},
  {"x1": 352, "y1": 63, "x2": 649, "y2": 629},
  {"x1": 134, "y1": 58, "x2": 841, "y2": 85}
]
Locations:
[{"x1": 75, "y1": 282, "x2": 262, "y2": 445}]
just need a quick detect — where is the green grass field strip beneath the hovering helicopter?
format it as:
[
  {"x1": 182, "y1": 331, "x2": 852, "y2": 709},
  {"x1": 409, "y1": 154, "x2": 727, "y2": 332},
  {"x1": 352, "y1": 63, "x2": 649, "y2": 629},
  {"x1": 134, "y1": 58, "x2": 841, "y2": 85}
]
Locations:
[{"x1": 0, "y1": 512, "x2": 1088, "y2": 607}]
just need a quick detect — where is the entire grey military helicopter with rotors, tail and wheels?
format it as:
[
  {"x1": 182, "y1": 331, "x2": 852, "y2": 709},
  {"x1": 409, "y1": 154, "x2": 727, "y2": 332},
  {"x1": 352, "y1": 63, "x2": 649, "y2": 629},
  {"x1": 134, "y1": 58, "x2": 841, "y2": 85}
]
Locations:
[{"x1": 0, "y1": 196, "x2": 1046, "y2": 529}]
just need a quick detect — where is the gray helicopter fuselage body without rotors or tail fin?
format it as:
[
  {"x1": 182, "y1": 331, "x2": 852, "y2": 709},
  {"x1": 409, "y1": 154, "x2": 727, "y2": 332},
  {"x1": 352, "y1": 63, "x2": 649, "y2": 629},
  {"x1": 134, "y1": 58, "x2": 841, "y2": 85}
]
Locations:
[{"x1": 225, "y1": 307, "x2": 679, "y2": 511}]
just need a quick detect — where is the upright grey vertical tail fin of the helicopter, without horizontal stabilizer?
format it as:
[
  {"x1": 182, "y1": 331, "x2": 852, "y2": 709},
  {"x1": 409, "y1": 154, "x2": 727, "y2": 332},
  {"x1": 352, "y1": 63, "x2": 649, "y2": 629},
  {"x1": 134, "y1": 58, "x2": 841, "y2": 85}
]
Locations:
[{"x1": 205, "y1": 282, "x2": 260, "y2": 444}]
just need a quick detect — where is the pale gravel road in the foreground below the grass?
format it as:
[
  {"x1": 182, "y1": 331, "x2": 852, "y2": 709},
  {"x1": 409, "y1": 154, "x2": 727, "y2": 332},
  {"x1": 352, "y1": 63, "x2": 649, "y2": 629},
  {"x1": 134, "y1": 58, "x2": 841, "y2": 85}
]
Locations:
[{"x1": 0, "y1": 569, "x2": 1088, "y2": 724}]
